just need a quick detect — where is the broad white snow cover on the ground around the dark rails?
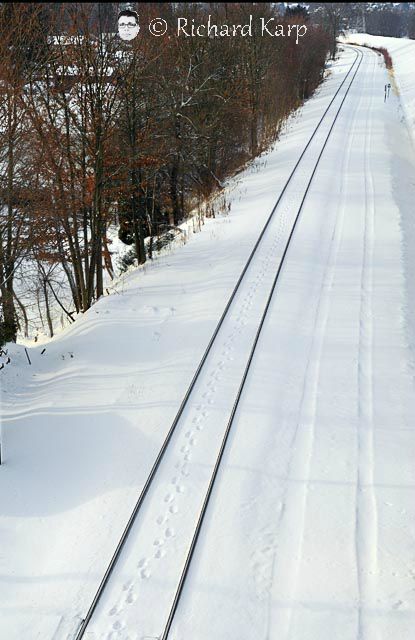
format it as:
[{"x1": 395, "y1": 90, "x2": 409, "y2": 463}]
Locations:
[{"x1": 0, "y1": 49, "x2": 415, "y2": 640}]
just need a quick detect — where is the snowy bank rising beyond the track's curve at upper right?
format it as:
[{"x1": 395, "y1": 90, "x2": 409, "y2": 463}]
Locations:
[{"x1": 342, "y1": 33, "x2": 415, "y2": 141}]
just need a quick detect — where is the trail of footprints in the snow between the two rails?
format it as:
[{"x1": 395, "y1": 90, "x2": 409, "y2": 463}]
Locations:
[{"x1": 98, "y1": 209, "x2": 292, "y2": 640}]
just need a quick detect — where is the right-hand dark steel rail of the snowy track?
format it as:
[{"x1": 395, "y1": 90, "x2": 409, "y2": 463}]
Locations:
[{"x1": 160, "y1": 45, "x2": 363, "y2": 640}]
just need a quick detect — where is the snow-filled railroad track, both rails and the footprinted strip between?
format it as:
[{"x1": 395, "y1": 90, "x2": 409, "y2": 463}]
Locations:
[{"x1": 76, "y1": 46, "x2": 362, "y2": 640}]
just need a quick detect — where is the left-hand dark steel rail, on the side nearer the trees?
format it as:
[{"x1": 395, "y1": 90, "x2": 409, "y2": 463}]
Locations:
[{"x1": 74, "y1": 47, "x2": 363, "y2": 640}]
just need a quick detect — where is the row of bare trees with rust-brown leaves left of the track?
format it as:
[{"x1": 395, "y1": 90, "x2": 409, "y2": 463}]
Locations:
[{"x1": 0, "y1": 3, "x2": 328, "y2": 344}]
